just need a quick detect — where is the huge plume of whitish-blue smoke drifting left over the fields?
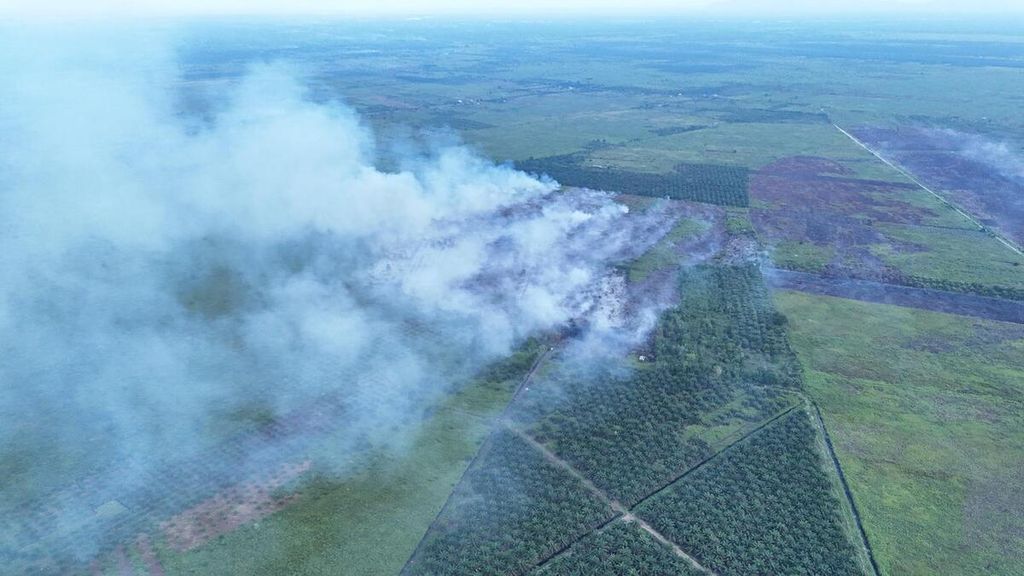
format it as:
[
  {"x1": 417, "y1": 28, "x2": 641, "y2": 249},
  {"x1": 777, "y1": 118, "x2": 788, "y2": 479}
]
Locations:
[{"x1": 0, "y1": 30, "x2": 696, "y2": 569}]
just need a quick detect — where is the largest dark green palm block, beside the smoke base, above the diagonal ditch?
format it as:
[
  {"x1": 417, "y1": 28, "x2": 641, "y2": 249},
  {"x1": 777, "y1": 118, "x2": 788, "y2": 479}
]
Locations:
[{"x1": 515, "y1": 265, "x2": 800, "y2": 504}]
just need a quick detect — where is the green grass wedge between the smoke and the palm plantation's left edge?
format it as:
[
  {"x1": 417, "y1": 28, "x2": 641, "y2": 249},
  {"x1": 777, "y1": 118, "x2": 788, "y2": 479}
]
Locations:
[{"x1": 156, "y1": 340, "x2": 545, "y2": 576}]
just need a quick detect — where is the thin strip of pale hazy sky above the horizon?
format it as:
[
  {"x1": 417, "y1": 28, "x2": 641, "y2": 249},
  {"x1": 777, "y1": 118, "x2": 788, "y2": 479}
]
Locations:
[{"x1": 0, "y1": 0, "x2": 1024, "y2": 17}]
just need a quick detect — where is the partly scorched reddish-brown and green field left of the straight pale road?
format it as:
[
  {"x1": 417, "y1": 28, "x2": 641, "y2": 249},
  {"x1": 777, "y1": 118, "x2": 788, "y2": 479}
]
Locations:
[{"x1": 751, "y1": 152, "x2": 1024, "y2": 297}]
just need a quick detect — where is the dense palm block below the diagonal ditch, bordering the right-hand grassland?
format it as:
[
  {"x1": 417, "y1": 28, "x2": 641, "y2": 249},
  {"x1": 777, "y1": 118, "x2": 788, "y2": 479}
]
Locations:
[{"x1": 636, "y1": 410, "x2": 862, "y2": 576}]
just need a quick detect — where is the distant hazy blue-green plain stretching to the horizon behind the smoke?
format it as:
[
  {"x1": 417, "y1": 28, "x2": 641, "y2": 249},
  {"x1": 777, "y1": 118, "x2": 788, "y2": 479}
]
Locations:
[{"x1": 180, "y1": 22, "x2": 1024, "y2": 178}]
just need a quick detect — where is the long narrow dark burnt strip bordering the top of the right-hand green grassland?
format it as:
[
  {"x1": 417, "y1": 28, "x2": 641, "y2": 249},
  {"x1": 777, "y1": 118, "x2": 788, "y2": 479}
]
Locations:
[{"x1": 764, "y1": 269, "x2": 1024, "y2": 324}]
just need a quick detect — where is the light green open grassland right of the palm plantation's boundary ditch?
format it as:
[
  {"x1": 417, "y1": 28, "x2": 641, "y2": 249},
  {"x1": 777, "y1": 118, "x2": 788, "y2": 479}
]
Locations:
[{"x1": 775, "y1": 292, "x2": 1024, "y2": 575}]
